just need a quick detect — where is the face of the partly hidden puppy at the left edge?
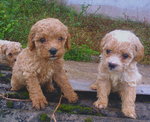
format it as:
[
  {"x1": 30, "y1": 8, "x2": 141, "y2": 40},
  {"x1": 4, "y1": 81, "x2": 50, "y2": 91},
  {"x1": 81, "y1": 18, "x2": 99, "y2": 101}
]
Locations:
[{"x1": 5, "y1": 43, "x2": 22, "y2": 67}]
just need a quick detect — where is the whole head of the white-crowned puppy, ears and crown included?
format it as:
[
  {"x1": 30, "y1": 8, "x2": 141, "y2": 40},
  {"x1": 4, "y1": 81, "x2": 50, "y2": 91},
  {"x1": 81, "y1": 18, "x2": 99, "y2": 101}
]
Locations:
[{"x1": 101, "y1": 30, "x2": 144, "y2": 72}]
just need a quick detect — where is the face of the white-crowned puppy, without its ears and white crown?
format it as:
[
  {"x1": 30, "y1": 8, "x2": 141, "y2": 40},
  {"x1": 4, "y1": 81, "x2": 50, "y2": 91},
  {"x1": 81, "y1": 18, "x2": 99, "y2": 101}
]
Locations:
[{"x1": 102, "y1": 41, "x2": 134, "y2": 72}]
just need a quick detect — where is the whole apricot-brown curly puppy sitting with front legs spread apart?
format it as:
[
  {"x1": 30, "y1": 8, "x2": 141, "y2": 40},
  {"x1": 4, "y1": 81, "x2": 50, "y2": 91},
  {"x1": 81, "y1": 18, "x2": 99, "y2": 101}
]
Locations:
[{"x1": 11, "y1": 18, "x2": 78, "y2": 109}]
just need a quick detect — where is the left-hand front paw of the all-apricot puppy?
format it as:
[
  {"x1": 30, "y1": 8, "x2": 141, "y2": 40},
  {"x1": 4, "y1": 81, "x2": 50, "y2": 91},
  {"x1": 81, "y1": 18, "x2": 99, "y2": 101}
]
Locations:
[{"x1": 31, "y1": 96, "x2": 48, "y2": 110}]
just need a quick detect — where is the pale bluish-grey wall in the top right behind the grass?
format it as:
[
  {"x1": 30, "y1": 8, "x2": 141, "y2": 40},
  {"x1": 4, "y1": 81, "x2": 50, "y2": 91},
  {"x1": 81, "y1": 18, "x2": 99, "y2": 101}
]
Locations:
[{"x1": 58, "y1": 0, "x2": 150, "y2": 23}]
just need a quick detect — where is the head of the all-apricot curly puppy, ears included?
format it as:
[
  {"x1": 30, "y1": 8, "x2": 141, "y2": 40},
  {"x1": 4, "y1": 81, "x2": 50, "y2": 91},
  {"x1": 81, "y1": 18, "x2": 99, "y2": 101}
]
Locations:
[{"x1": 28, "y1": 18, "x2": 69, "y2": 60}]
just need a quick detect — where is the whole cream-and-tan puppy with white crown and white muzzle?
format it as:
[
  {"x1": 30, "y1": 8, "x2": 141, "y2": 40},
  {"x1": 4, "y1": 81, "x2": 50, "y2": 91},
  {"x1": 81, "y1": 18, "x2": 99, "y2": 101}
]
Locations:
[{"x1": 91, "y1": 30, "x2": 144, "y2": 118}]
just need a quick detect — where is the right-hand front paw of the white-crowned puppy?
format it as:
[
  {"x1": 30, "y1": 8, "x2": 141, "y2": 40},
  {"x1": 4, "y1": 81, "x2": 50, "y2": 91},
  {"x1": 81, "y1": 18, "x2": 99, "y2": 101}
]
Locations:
[{"x1": 122, "y1": 107, "x2": 136, "y2": 119}]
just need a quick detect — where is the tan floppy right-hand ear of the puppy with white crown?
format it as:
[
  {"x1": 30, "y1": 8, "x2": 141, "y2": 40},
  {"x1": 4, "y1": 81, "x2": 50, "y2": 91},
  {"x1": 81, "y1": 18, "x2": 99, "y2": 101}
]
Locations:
[{"x1": 134, "y1": 40, "x2": 144, "y2": 62}]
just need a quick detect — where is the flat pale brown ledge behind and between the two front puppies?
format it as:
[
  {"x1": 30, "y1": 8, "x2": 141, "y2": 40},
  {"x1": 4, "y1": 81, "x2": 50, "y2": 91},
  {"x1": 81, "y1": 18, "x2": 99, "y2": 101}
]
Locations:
[{"x1": 65, "y1": 61, "x2": 150, "y2": 94}]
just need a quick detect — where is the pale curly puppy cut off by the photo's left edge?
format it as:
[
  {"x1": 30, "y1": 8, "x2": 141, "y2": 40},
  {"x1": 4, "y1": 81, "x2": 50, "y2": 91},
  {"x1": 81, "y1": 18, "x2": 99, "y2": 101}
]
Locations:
[{"x1": 0, "y1": 40, "x2": 22, "y2": 67}]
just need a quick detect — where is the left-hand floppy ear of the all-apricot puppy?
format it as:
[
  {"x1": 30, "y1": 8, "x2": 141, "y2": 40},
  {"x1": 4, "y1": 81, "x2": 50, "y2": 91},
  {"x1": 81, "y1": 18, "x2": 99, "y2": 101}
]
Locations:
[{"x1": 28, "y1": 29, "x2": 35, "y2": 51}]
